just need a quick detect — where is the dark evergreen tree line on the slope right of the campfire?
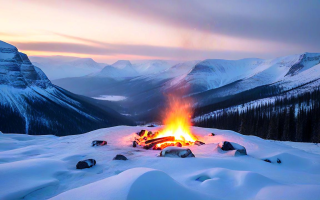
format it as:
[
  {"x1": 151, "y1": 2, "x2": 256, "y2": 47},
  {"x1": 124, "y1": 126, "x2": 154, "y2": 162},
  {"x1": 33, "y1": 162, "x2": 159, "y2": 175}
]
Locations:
[{"x1": 195, "y1": 88, "x2": 320, "y2": 143}]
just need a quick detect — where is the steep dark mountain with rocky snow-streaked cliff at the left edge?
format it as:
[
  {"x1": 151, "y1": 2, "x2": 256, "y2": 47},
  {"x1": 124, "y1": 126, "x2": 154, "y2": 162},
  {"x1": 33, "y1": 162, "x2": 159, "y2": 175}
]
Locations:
[{"x1": 0, "y1": 41, "x2": 133, "y2": 136}]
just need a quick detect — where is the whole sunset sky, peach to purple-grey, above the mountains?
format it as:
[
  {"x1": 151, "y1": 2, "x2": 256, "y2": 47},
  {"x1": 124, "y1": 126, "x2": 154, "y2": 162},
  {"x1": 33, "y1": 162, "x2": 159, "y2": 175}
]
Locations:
[{"x1": 0, "y1": 0, "x2": 320, "y2": 62}]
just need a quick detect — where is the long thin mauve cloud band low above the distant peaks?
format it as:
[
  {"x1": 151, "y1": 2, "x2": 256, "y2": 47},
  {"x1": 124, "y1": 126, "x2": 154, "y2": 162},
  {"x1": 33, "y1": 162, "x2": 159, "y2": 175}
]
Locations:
[{"x1": 11, "y1": 38, "x2": 300, "y2": 60}]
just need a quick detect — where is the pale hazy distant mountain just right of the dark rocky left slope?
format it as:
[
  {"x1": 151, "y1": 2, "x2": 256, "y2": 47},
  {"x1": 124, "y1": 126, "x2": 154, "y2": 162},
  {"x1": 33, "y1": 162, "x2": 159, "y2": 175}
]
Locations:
[{"x1": 30, "y1": 56, "x2": 105, "y2": 80}]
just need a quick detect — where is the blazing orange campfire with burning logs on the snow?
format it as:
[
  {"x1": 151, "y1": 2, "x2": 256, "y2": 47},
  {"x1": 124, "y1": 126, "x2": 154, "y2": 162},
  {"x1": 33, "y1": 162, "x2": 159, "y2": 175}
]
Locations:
[{"x1": 133, "y1": 96, "x2": 204, "y2": 150}]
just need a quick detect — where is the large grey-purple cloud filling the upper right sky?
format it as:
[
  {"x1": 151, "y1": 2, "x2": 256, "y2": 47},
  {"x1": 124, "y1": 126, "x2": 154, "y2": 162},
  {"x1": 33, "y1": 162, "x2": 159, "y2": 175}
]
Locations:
[{"x1": 84, "y1": 0, "x2": 320, "y2": 51}]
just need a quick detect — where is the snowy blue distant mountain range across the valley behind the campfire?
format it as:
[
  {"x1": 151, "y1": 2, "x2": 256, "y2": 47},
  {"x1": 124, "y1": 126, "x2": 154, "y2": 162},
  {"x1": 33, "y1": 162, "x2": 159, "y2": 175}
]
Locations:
[{"x1": 53, "y1": 53, "x2": 320, "y2": 120}]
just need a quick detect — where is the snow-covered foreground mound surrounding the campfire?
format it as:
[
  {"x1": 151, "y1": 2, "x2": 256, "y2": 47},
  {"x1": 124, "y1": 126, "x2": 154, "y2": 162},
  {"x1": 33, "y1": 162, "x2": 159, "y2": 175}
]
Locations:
[{"x1": 0, "y1": 126, "x2": 320, "y2": 200}]
